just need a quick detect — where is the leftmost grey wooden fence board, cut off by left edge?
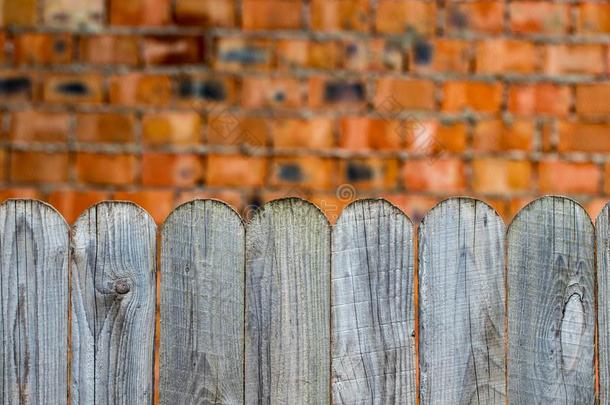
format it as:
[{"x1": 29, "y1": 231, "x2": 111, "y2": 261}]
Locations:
[{"x1": 0, "y1": 200, "x2": 70, "y2": 404}]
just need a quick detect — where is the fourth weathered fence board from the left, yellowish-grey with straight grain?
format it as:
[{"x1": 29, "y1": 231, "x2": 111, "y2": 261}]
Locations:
[{"x1": 245, "y1": 198, "x2": 330, "y2": 405}]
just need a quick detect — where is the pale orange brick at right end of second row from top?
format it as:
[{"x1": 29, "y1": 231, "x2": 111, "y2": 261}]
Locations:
[{"x1": 544, "y1": 44, "x2": 605, "y2": 75}]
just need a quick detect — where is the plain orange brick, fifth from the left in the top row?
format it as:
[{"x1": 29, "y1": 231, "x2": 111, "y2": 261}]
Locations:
[{"x1": 242, "y1": 0, "x2": 303, "y2": 30}]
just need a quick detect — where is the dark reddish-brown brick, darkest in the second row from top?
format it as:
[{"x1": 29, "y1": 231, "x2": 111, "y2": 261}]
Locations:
[{"x1": 142, "y1": 35, "x2": 203, "y2": 65}]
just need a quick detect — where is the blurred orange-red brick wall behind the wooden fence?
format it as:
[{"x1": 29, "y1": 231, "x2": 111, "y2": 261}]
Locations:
[{"x1": 0, "y1": 0, "x2": 610, "y2": 222}]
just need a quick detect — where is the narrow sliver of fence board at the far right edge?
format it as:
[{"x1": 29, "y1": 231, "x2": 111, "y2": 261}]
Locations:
[{"x1": 595, "y1": 204, "x2": 610, "y2": 405}]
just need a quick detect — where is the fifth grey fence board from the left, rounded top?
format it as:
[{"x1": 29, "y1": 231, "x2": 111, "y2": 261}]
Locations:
[{"x1": 331, "y1": 200, "x2": 417, "y2": 405}]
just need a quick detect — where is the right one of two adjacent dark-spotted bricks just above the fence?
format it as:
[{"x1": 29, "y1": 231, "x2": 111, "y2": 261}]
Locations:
[{"x1": 339, "y1": 158, "x2": 398, "y2": 190}]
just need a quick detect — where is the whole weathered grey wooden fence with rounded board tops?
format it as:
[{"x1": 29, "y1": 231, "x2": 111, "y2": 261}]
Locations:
[{"x1": 0, "y1": 197, "x2": 610, "y2": 405}]
